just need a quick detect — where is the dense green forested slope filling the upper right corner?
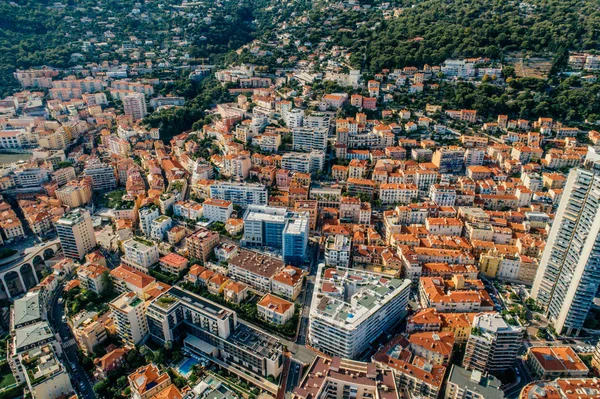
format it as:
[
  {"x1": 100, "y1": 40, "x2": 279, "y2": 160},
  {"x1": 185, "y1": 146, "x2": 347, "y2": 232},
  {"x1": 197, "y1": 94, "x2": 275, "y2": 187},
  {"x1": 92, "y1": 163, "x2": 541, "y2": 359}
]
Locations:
[{"x1": 360, "y1": 0, "x2": 600, "y2": 71}]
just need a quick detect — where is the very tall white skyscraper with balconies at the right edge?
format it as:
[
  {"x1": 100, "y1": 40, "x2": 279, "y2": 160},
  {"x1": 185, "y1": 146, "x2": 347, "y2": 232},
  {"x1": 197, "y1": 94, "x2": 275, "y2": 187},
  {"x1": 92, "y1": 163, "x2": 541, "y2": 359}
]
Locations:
[{"x1": 531, "y1": 155, "x2": 600, "y2": 335}]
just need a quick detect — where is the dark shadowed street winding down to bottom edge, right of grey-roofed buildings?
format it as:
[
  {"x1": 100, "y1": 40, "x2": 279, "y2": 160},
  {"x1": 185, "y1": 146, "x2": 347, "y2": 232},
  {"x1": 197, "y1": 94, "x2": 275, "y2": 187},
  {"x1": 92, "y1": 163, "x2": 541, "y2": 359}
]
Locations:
[{"x1": 48, "y1": 278, "x2": 97, "y2": 399}]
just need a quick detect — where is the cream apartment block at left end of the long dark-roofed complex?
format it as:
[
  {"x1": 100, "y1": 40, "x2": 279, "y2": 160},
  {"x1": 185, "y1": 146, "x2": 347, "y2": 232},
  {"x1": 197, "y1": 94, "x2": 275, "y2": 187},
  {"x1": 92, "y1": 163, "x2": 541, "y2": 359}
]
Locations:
[{"x1": 110, "y1": 292, "x2": 148, "y2": 346}]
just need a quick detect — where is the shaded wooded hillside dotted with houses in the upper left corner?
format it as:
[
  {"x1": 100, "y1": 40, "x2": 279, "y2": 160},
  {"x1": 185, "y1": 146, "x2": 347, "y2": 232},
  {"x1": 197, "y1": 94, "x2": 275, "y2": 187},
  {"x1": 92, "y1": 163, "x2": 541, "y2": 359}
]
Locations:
[{"x1": 0, "y1": 0, "x2": 310, "y2": 96}]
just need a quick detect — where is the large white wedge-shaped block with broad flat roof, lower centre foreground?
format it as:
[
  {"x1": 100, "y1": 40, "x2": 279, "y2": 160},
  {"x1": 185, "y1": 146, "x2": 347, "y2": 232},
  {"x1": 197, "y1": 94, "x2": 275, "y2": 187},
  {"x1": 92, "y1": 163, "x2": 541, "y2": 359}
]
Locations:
[{"x1": 308, "y1": 264, "x2": 410, "y2": 359}]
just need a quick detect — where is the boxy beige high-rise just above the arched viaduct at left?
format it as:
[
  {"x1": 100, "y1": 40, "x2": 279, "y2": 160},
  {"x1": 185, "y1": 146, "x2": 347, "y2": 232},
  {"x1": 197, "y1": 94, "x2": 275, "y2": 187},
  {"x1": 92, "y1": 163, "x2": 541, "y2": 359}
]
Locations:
[{"x1": 56, "y1": 208, "x2": 96, "y2": 260}]
